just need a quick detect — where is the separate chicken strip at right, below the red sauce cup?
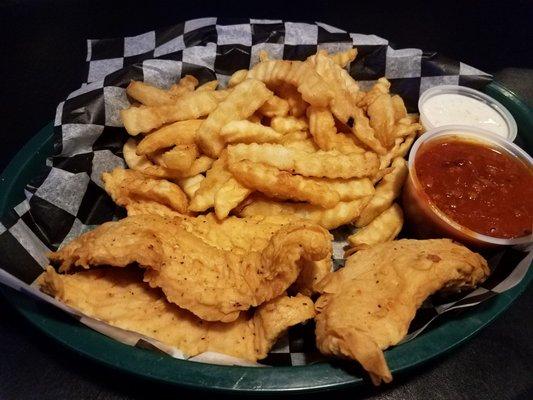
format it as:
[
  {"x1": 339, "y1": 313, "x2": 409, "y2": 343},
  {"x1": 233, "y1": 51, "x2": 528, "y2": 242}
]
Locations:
[{"x1": 316, "y1": 239, "x2": 490, "y2": 385}]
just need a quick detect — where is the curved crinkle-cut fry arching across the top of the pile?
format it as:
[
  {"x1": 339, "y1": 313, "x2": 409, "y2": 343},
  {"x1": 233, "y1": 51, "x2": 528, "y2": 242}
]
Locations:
[{"x1": 248, "y1": 60, "x2": 332, "y2": 107}]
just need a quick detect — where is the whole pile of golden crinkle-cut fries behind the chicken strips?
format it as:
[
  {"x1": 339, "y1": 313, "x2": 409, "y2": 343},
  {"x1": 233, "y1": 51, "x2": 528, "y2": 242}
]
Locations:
[{"x1": 118, "y1": 49, "x2": 422, "y2": 250}]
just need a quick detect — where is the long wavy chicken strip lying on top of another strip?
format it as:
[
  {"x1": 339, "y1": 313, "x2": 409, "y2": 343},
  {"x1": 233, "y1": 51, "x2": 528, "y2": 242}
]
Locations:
[{"x1": 50, "y1": 215, "x2": 331, "y2": 322}]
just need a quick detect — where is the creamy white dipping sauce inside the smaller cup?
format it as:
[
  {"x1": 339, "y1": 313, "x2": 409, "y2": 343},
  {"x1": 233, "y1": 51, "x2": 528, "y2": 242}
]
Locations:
[{"x1": 422, "y1": 93, "x2": 509, "y2": 137}]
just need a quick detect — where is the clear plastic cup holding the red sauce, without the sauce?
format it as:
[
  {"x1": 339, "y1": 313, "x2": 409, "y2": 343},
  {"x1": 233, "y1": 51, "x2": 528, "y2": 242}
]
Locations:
[{"x1": 402, "y1": 125, "x2": 533, "y2": 248}]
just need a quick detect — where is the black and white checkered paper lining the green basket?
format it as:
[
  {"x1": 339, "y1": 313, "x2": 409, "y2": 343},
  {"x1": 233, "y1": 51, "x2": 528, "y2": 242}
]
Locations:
[{"x1": 0, "y1": 18, "x2": 533, "y2": 365}]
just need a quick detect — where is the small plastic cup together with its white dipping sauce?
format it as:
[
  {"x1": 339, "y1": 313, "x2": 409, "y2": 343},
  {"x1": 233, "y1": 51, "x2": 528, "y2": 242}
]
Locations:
[{"x1": 418, "y1": 85, "x2": 517, "y2": 142}]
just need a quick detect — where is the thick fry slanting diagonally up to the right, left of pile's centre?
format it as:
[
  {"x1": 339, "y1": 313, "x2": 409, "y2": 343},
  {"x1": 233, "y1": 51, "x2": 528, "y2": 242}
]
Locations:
[{"x1": 197, "y1": 79, "x2": 273, "y2": 157}]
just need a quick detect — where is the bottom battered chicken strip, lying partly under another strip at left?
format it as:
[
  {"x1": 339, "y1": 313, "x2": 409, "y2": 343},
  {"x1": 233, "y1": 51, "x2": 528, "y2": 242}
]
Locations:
[{"x1": 38, "y1": 267, "x2": 314, "y2": 361}]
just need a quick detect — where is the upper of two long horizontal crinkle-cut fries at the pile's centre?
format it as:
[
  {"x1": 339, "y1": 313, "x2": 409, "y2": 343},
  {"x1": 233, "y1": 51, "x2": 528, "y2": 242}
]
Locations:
[{"x1": 228, "y1": 143, "x2": 379, "y2": 178}]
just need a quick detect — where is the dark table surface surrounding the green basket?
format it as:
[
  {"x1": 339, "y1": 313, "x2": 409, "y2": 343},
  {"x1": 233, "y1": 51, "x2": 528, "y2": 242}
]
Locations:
[{"x1": 0, "y1": 0, "x2": 533, "y2": 400}]
